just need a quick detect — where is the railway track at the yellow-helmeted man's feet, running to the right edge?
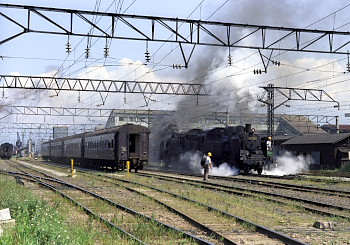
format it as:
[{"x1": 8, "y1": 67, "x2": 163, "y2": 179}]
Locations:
[{"x1": 140, "y1": 169, "x2": 350, "y2": 220}]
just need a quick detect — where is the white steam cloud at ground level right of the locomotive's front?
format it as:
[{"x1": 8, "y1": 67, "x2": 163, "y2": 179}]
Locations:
[{"x1": 264, "y1": 152, "x2": 314, "y2": 176}]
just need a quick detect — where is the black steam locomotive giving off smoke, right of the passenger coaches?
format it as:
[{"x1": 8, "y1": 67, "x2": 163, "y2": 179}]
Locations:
[{"x1": 160, "y1": 124, "x2": 267, "y2": 174}]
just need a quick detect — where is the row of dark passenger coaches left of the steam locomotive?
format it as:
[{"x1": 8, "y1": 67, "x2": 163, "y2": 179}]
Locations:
[{"x1": 42, "y1": 124, "x2": 150, "y2": 172}]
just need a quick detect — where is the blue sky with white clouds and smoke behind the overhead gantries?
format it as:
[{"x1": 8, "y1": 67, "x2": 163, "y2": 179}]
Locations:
[{"x1": 0, "y1": 0, "x2": 350, "y2": 144}]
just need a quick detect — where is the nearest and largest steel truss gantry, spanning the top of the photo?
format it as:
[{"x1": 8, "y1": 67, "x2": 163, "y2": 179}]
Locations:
[{"x1": 0, "y1": 4, "x2": 350, "y2": 54}]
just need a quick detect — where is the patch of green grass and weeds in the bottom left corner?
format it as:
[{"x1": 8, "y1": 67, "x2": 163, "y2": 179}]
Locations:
[{"x1": 0, "y1": 175, "x2": 129, "y2": 245}]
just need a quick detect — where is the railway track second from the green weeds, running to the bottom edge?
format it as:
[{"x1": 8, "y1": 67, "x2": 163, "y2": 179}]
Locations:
[{"x1": 0, "y1": 160, "x2": 305, "y2": 244}]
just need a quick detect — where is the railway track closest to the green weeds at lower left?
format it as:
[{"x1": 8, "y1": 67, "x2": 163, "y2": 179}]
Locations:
[{"x1": 3, "y1": 161, "x2": 216, "y2": 244}]
